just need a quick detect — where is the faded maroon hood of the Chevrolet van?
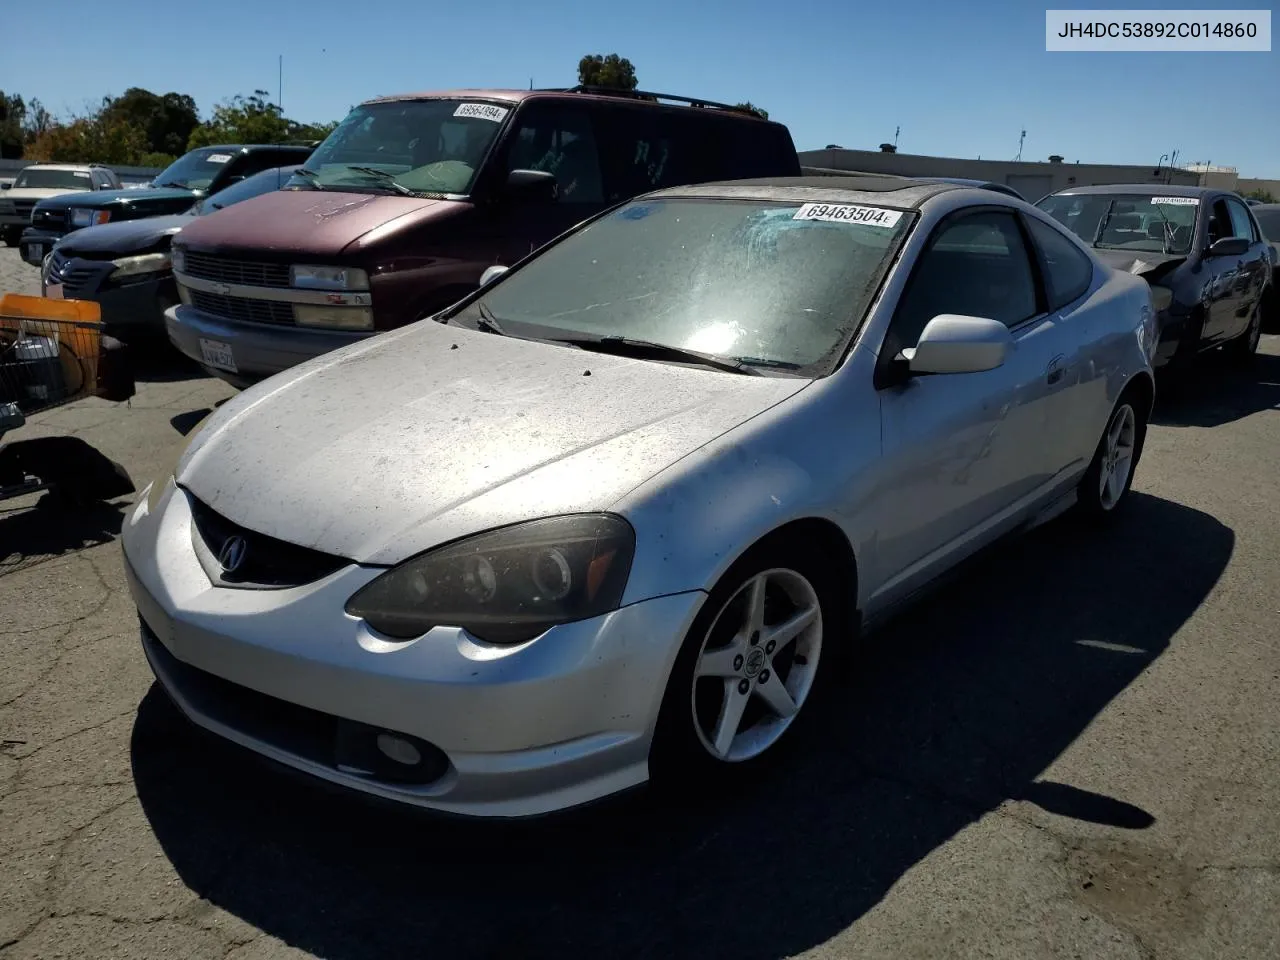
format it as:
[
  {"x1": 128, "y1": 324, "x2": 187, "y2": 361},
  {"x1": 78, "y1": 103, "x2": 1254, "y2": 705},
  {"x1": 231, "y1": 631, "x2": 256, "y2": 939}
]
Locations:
[{"x1": 172, "y1": 189, "x2": 467, "y2": 257}]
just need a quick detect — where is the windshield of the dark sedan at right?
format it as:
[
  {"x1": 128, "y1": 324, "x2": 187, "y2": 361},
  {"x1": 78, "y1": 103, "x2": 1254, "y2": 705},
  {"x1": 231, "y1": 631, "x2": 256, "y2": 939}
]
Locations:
[{"x1": 1036, "y1": 193, "x2": 1199, "y2": 255}]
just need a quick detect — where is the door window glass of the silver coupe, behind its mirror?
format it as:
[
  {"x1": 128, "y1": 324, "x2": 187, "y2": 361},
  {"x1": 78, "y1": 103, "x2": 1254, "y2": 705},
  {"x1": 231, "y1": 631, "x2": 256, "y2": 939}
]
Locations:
[{"x1": 887, "y1": 211, "x2": 1039, "y2": 353}]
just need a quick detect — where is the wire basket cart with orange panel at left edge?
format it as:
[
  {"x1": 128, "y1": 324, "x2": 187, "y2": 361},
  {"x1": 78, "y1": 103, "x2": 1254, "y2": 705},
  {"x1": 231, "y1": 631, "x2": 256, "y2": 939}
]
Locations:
[{"x1": 0, "y1": 294, "x2": 102, "y2": 415}]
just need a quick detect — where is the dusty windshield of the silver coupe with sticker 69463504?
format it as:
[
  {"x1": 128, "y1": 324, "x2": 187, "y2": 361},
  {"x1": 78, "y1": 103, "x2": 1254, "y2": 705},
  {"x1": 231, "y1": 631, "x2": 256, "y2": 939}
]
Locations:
[{"x1": 457, "y1": 200, "x2": 911, "y2": 370}]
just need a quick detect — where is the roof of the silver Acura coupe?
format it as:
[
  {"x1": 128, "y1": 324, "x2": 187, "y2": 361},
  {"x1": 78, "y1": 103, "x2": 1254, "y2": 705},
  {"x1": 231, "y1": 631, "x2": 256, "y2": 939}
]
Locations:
[{"x1": 645, "y1": 177, "x2": 964, "y2": 209}]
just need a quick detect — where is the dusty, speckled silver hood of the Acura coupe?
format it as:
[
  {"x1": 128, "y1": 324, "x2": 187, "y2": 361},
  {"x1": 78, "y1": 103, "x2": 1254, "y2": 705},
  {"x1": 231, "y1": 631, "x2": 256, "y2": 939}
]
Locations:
[{"x1": 177, "y1": 320, "x2": 809, "y2": 564}]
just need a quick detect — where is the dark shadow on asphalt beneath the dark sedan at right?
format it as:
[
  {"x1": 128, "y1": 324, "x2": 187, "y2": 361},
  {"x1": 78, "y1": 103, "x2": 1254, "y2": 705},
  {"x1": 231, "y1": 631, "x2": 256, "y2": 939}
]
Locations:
[{"x1": 1151, "y1": 343, "x2": 1280, "y2": 426}]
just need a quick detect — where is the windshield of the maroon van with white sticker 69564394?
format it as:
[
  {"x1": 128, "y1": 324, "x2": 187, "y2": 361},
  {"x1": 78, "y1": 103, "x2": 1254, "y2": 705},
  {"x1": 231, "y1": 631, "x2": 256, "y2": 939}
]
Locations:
[{"x1": 293, "y1": 100, "x2": 511, "y2": 193}]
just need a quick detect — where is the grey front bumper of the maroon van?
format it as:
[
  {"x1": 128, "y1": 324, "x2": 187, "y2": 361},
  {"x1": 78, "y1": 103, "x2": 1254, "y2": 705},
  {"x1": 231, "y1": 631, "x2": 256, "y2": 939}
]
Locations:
[{"x1": 165, "y1": 303, "x2": 372, "y2": 387}]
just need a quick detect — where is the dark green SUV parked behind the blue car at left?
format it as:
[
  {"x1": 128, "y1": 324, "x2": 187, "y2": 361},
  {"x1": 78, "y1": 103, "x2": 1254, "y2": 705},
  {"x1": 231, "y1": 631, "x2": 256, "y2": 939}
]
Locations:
[{"x1": 22, "y1": 143, "x2": 314, "y2": 266}]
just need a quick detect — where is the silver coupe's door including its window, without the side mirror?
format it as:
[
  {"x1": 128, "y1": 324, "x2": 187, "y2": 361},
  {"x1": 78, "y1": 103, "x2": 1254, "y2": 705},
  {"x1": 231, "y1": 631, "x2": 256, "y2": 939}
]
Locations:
[{"x1": 877, "y1": 207, "x2": 1071, "y2": 602}]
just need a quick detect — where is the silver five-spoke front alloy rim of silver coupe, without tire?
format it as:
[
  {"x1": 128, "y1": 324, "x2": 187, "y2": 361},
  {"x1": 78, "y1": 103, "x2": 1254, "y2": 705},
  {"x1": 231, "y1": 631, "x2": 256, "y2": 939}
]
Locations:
[{"x1": 691, "y1": 568, "x2": 823, "y2": 763}]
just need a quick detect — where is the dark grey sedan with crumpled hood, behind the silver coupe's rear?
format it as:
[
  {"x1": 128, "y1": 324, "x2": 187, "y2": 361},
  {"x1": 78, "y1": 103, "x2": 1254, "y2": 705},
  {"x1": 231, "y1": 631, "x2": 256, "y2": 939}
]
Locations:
[{"x1": 1036, "y1": 183, "x2": 1272, "y2": 367}]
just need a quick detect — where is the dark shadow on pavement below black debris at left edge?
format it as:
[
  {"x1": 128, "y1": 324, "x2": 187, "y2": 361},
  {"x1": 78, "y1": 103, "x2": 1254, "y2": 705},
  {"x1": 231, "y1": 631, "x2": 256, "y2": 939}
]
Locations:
[{"x1": 0, "y1": 492, "x2": 128, "y2": 577}]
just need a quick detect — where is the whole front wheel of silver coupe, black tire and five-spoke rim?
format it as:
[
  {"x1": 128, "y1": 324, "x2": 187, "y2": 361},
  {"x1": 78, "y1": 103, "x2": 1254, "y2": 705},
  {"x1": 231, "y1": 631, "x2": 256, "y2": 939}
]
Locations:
[{"x1": 649, "y1": 539, "x2": 842, "y2": 791}]
